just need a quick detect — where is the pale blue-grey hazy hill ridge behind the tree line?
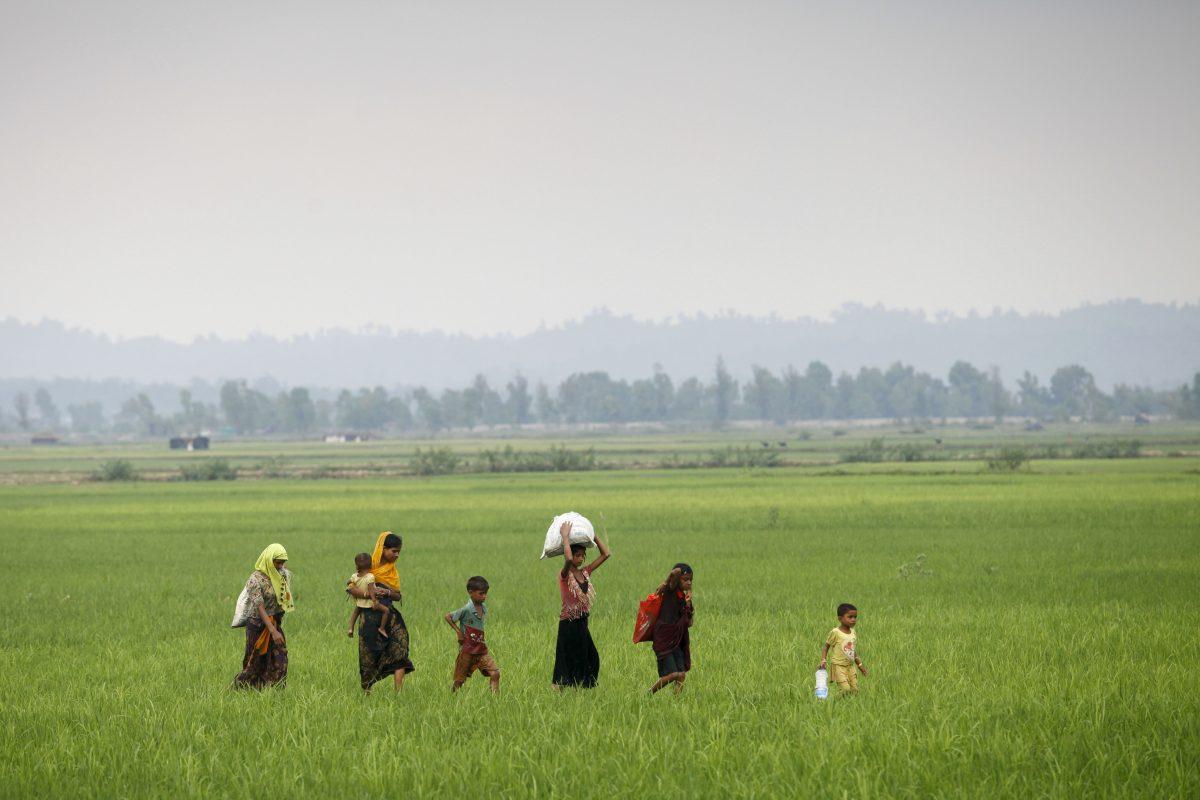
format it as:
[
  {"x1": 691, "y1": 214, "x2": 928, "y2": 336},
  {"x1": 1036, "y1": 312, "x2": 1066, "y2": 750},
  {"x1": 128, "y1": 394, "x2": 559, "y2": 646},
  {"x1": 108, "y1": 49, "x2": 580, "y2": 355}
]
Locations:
[{"x1": 0, "y1": 300, "x2": 1200, "y2": 389}]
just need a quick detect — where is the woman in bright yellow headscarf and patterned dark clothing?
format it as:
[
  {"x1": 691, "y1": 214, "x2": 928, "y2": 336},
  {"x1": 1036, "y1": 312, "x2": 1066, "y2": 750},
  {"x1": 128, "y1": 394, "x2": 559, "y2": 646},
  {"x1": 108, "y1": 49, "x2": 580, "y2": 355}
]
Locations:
[{"x1": 233, "y1": 543, "x2": 296, "y2": 688}]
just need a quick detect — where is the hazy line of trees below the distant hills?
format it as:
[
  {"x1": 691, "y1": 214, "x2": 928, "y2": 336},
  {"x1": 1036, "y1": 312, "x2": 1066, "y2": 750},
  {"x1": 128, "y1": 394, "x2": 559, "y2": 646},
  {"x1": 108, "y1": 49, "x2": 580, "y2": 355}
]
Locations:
[{"x1": 0, "y1": 359, "x2": 1200, "y2": 437}]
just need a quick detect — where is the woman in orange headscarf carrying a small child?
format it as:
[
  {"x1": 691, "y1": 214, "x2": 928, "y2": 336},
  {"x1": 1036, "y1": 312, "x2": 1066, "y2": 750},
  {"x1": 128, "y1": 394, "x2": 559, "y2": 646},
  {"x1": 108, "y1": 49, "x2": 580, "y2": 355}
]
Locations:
[{"x1": 346, "y1": 530, "x2": 415, "y2": 692}]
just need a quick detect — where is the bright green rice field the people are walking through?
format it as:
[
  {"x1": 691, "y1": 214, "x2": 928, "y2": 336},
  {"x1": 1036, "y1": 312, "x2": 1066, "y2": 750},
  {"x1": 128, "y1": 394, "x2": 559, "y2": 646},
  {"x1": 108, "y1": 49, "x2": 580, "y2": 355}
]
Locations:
[{"x1": 0, "y1": 457, "x2": 1200, "y2": 798}]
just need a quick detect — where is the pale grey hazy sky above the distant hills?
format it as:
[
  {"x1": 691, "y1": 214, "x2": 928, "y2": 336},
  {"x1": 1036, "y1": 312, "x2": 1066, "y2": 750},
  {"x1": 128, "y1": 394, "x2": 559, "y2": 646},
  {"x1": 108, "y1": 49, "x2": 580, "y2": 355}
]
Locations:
[{"x1": 0, "y1": 0, "x2": 1200, "y2": 338}]
